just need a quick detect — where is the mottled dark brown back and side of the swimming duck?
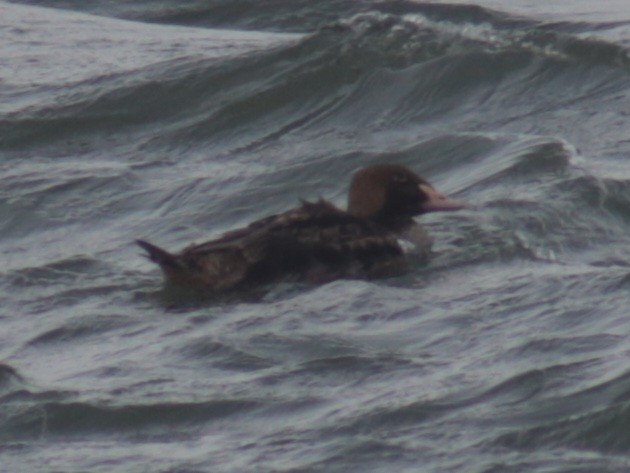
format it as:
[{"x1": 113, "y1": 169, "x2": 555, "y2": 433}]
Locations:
[{"x1": 152, "y1": 200, "x2": 405, "y2": 290}]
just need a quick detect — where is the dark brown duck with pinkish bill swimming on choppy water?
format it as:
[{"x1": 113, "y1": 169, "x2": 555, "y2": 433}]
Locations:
[{"x1": 136, "y1": 164, "x2": 464, "y2": 292}]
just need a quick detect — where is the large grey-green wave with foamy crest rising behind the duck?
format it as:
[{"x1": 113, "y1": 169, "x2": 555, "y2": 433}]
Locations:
[{"x1": 0, "y1": 2, "x2": 628, "y2": 153}]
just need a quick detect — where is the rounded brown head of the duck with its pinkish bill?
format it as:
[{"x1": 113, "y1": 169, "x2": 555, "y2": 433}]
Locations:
[{"x1": 348, "y1": 164, "x2": 464, "y2": 229}]
